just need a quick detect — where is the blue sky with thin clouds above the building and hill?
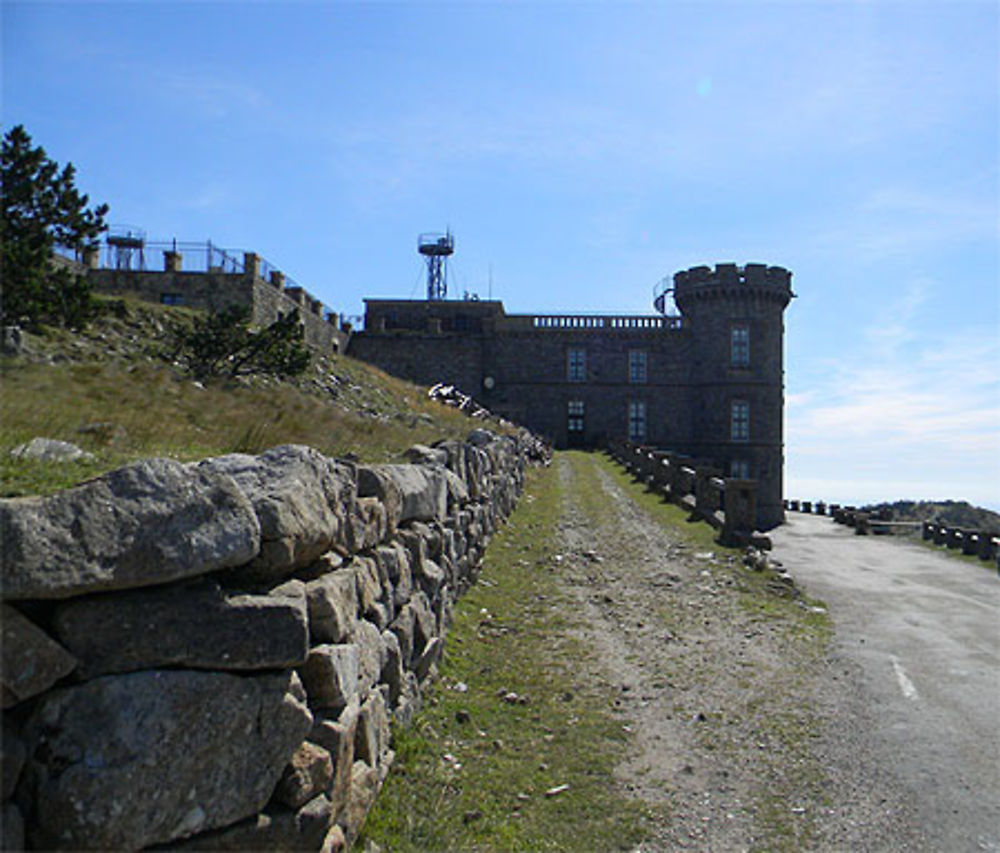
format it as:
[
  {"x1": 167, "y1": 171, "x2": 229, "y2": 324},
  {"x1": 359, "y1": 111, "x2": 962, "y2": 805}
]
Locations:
[{"x1": 2, "y1": 0, "x2": 1000, "y2": 508}]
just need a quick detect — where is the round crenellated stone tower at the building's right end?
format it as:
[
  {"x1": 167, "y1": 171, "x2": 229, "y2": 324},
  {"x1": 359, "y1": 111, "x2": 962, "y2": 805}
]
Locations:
[{"x1": 673, "y1": 264, "x2": 794, "y2": 530}]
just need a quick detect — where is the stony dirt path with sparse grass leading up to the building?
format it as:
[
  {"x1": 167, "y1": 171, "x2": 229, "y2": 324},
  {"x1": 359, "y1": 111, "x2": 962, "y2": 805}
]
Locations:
[{"x1": 555, "y1": 454, "x2": 934, "y2": 851}]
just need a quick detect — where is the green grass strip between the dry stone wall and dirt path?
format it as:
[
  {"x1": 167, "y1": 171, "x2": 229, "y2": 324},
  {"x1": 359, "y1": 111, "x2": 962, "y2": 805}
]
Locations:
[{"x1": 359, "y1": 469, "x2": 644, "y2": 851}]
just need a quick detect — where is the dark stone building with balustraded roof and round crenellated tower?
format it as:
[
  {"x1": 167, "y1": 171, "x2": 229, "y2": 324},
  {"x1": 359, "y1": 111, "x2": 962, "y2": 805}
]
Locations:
[{"x1": 348, "y1": 264, "x2": 793, "y2": 529}]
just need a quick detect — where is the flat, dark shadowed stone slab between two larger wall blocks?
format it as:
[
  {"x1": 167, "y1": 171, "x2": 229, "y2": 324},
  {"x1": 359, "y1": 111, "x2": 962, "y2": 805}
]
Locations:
[{"x1": 53, "y1": 579, "x2": 309, "y2": 678}]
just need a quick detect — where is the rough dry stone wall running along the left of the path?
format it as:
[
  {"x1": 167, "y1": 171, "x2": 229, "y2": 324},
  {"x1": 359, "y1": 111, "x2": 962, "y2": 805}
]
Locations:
[{"x1": 0, "y1": 430, "x2": 538, "y2": 851}]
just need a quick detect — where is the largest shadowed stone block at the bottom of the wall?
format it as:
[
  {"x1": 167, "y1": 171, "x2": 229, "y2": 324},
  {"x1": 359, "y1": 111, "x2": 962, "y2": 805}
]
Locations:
[{"x1": 25, "y1": 670, "x2": 312, "y2": 850}]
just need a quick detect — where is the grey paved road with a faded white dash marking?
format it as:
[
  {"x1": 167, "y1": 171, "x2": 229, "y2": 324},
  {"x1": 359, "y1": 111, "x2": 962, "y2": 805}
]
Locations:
[{"x1": 772, "y1": 513, "x2": 1000, "y2": 851}]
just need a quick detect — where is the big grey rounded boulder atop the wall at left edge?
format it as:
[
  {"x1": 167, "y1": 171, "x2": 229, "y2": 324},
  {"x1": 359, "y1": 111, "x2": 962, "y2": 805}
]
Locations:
[{"x1": 0, "y1": 459, "x2": 260, "y2": 600}]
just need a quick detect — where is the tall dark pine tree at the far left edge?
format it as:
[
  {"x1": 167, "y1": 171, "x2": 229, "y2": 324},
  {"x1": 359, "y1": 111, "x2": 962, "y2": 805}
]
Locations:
[{"x1": 0, "y1": 125, "x2": 108, "y2": 328}]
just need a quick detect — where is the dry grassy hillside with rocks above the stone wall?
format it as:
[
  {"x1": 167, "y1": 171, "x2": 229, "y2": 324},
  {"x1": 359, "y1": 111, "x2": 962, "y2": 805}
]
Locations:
[{"x1": 0, "y1": 299, "x2": 504, "y2": 496}]
